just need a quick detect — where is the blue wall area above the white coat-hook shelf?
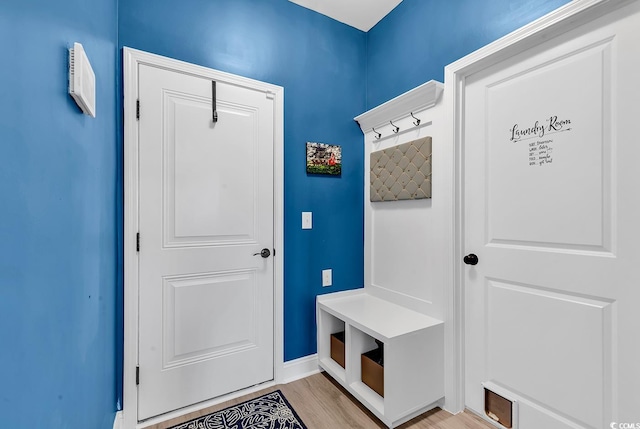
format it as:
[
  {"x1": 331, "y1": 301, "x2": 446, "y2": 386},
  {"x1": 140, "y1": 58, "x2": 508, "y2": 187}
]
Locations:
[{"x1": 367, "y1": 0, "x2": 568, "y2": 109}]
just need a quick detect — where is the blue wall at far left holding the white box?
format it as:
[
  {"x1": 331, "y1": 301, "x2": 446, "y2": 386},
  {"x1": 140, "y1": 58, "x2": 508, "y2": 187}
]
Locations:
[{"x1": 0, "y1": 0, "x2": 117, "y2": 429}]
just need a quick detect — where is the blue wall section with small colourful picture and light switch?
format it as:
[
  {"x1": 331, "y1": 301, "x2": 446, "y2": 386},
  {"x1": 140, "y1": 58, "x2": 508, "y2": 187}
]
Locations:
[{"x1": 119, "y1": 0, "x2": 366, "y2": 360}]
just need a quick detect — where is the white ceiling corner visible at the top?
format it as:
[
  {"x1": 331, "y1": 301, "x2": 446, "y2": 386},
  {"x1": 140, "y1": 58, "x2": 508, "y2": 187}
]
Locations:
[{"x1": 289, "y1": 0, "x2": 402, "y2": 31}]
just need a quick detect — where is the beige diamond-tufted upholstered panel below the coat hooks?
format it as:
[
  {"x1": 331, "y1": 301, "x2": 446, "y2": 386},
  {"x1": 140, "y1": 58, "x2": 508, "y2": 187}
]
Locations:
[{"x1": 370, "y1": 137, "x2": 431, "y2": 202}]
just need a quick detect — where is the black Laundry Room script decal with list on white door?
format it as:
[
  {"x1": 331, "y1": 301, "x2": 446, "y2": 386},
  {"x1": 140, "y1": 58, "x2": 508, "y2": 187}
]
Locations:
[{"x1": 509, "y1": 116, "x2": 571, "y2": 167}]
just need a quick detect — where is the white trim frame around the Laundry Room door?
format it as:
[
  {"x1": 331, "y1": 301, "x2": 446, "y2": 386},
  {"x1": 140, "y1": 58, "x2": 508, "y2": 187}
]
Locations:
[{"x1": 443, "y1": 0, "x2": 637, "y2": 414}]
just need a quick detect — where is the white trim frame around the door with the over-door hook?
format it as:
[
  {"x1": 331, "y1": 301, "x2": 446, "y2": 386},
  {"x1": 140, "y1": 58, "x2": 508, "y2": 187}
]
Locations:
[{"x1": 122, "y1": 47, "x2": 284, "y2": 429}]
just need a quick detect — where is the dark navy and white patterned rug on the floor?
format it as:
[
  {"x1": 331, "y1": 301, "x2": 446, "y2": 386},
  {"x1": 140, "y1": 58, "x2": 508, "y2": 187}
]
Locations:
[{"x1": 169, "y1": 390, "x2": 307, "y2": 429}]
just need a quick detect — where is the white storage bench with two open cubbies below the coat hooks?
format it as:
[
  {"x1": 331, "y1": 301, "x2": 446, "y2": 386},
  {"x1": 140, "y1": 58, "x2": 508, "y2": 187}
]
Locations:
[{"x1": 317, "y1": 290, "x2": 444, "y2": 428}]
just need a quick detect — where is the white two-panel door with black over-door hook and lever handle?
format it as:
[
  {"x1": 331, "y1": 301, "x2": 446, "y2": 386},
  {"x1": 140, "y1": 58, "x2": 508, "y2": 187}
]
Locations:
[{"x1": 138, "y1": 65, "x2": 274, "y2": 420}]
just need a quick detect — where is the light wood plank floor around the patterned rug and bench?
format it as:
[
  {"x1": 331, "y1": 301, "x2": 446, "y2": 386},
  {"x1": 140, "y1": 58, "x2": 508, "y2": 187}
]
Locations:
[{"x1": 148, "y1": 373, "x2": 495, "y2": 429}]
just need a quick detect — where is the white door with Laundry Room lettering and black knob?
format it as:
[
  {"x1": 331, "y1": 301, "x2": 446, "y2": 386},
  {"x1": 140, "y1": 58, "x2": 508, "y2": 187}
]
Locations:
[{"x1": 463, "y1": 2, "x2": 640, "y2": 429}]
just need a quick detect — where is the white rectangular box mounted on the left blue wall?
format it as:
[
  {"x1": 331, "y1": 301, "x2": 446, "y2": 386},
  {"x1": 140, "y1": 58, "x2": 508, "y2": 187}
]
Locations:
[{"x1": 69, "y1": 42, "x2": 96, "y2": 118}]
